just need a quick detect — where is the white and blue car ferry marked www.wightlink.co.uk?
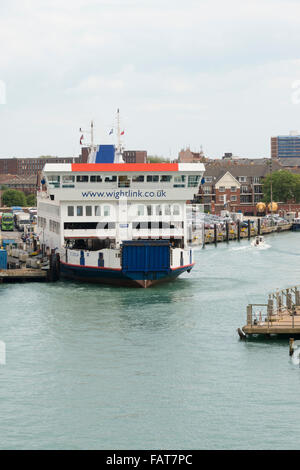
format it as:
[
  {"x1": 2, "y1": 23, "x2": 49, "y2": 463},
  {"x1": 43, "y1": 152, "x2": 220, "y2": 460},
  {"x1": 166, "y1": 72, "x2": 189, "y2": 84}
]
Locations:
[{"x1": 36, "y1": 125, "x2": 204, "y2": 288}]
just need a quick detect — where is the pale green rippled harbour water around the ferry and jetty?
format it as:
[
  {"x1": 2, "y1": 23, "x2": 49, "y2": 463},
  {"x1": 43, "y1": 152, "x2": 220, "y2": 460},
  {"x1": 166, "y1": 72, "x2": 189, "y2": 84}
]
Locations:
[{"x1": 0, "y1": 232, "x2": 300, "y2": 449}]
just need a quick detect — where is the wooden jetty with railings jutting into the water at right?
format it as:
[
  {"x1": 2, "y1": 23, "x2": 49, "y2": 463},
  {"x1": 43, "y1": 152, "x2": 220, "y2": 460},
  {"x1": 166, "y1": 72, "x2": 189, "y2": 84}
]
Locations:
[{"x1": 238, "y1": 286, "x2": 300, "y2": 339}]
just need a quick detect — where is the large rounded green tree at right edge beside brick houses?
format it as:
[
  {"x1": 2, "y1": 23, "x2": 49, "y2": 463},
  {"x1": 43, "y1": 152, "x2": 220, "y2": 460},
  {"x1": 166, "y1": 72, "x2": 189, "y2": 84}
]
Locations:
[{"x1": 263, "y1": 170, "x2": 300, "y2": 202}]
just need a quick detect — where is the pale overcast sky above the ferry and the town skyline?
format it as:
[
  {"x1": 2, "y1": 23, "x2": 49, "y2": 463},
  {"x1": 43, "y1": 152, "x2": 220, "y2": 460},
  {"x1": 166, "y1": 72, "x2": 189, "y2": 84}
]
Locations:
[{"x1": 0, "y1": 0, "x2": 300, "y2": 158}]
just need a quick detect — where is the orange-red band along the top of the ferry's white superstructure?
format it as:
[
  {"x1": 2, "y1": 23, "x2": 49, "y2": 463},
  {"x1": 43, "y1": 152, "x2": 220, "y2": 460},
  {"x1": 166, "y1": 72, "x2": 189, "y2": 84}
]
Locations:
[{"x1": 72, "y1": 163, "x2": 178, "y2": 173}]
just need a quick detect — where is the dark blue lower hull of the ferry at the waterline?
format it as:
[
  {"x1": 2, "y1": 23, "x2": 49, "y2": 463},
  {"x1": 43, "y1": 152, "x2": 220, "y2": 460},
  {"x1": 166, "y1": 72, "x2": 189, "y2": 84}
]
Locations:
[{"x1": 60, "y1": 262, "x2": 193, "y2": 287}]
